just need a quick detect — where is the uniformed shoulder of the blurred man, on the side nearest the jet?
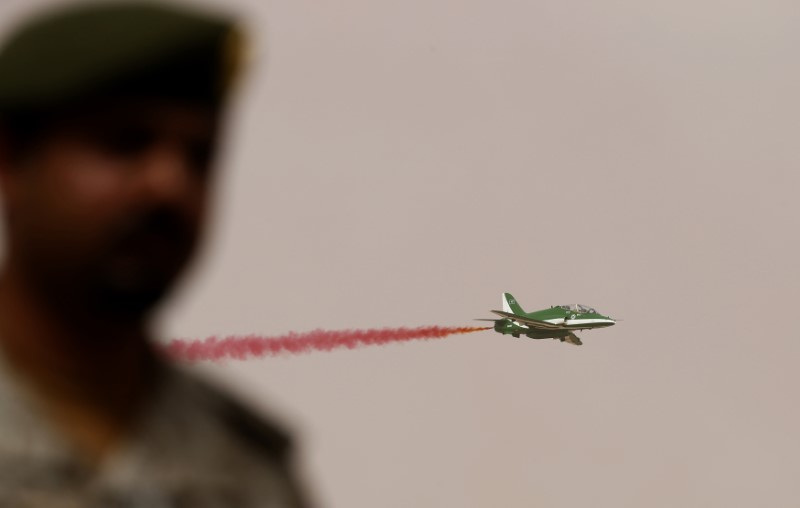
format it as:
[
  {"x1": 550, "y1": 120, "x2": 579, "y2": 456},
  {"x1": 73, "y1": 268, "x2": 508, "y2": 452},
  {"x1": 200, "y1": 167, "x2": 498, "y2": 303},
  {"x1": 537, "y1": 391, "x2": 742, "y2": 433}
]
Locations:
[{"x1": 99, "y1": 365, "x2": 306, "y2": 507}]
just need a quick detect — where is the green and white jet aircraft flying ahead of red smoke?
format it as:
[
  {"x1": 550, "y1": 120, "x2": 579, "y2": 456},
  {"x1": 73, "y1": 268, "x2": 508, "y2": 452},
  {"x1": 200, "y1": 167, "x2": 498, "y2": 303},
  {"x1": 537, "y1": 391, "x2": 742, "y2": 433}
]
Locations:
[{"x1": 480, "y1": 293, "x2": 616, "y2": 346}]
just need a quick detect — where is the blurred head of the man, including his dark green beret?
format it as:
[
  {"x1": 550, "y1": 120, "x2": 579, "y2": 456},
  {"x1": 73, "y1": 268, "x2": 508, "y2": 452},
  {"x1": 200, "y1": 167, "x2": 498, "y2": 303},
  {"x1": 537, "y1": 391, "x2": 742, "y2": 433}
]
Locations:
[{"x1": 0, "y1": 3, "x2": 242, "y2": 318}]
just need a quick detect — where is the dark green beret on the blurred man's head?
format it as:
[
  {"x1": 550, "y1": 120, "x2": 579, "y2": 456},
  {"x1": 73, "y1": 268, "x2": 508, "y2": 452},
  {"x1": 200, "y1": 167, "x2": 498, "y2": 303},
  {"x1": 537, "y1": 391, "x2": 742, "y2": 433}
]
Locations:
[{"x1": 0, "y1": 2, "x2": 240, "y2": 112}]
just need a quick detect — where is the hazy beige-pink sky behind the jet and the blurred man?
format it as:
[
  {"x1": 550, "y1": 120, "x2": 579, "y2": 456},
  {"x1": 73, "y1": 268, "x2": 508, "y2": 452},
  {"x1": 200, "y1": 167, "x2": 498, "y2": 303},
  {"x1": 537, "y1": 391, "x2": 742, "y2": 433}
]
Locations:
[{"x1": 0, "y1": 0, "x2": 800, "y2": 508}]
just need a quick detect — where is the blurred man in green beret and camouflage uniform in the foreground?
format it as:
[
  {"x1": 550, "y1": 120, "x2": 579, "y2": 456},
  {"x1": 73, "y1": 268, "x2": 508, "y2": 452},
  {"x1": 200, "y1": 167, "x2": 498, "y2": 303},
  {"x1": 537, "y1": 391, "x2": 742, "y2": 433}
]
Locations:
[{"x1": 0, "y1": 3, "x2": 302, "y2": 507}]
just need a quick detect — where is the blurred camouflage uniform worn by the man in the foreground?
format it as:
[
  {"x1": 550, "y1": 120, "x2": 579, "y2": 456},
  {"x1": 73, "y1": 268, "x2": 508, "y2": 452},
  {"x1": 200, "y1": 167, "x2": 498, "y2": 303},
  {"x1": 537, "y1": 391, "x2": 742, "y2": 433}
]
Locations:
[{"x1": 0, "y1": 365, "x2": 304, "y2": 508}]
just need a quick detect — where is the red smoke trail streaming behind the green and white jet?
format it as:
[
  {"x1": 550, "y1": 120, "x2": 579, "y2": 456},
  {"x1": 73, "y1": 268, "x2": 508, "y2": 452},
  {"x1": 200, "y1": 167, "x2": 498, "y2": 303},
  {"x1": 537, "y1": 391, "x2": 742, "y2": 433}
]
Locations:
[{"x1": 165, "y1": 326, "x2": 490, "y2": 362}]
